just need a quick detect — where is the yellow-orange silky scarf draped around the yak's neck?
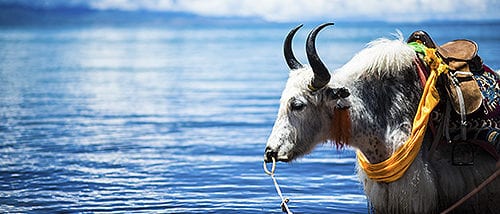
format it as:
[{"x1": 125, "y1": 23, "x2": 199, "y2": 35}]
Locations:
[{"x1": 357, "y1": 48, "x2": 448, "y2": 182}]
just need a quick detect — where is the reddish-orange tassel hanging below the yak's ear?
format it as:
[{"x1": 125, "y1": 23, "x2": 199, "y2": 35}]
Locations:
[{"x1": 331, "y1": 108, "x2": 351, "y2": 149}]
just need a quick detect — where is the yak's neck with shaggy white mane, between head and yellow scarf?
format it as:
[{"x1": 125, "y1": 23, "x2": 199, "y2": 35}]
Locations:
[{"x1": 326, "y1": 36, "x2": 422, "y2": 163}]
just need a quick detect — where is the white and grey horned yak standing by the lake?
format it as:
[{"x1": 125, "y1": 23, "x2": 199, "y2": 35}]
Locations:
[{"x1": 264, "y1": 23, "x2": 500, "y2": 213}]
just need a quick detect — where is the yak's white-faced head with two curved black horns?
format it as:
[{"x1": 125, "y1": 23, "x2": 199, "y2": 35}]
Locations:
[{"x1": 264, "y1": 23, "x2": 349, "y2": 162}]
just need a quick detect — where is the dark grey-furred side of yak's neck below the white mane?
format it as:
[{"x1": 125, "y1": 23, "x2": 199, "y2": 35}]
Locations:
[{"x1": 338, "y1": 69, "x2": 422, "y2": 163}]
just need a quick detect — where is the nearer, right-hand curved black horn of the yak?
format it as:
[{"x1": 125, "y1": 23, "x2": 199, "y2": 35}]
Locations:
[{"x1": 306, "y1": 23, "x2": 333, "y2": 91}]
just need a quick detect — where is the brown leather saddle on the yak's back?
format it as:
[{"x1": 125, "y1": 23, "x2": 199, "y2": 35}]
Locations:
[{"x1": 407, "y1": 30, "x2": 483, "y2": 115}]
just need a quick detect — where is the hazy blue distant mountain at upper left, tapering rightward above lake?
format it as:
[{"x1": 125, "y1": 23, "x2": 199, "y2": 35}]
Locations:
[{"x1": 0, "y1": 4, "x2": 268, "y2": 26}]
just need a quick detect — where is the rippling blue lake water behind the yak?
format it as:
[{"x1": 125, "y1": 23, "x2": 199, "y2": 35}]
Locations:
[{"x1": 0, "y1": 23, "x2": 500, "y2": 213}]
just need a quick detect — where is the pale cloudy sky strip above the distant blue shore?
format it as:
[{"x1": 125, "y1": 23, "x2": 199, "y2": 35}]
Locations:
[{"x1": 0, "y1": 0, "x2": 500, "y2": 22}]
